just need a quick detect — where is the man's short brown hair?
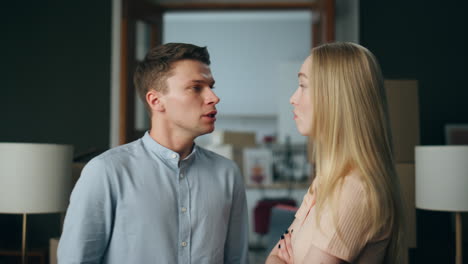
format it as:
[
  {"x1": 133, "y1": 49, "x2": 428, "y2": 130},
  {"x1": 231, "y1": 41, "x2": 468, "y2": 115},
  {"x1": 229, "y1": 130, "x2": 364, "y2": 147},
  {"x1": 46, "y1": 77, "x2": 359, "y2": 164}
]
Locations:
[{"x1": 133, "y1": 43, "x2": 211, "y2": 114}]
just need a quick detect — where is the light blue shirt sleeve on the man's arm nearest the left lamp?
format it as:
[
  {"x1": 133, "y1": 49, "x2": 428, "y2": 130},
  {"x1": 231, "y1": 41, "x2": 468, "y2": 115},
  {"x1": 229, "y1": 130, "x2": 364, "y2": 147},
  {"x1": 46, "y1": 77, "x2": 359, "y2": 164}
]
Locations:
[{"x1": 57, "y1": 160, "x2": 113, "y2": 264}]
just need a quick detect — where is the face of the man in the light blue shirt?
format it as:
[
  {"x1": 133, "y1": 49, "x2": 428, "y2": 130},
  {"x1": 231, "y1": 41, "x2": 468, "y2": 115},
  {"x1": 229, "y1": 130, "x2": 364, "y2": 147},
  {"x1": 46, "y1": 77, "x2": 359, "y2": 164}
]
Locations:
[{"x1": 160, "y1": 60, "x2": 219, "y2": 138}]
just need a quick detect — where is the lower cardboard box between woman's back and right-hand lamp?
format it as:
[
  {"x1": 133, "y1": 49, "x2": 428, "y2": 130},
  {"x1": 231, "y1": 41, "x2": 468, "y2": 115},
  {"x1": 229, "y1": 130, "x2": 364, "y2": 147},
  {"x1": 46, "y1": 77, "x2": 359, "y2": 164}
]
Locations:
[{"x1": 396, "y1": 163, "x2": 416, "y2": 248}]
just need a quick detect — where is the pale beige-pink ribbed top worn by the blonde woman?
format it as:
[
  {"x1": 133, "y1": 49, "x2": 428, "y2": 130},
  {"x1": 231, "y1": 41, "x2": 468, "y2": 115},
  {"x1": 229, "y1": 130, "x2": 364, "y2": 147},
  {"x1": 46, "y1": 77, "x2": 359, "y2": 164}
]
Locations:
[{"x1": 291, "y1": 173, "x2": 389, "y2": 264}]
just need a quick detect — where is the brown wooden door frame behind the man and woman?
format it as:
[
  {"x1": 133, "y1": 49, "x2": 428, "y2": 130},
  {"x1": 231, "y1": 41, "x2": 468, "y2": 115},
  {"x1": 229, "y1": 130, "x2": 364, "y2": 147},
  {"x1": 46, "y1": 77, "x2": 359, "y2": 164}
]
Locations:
[{"x1": 118, "y1": 0, "x2": 335, "y2": 144}]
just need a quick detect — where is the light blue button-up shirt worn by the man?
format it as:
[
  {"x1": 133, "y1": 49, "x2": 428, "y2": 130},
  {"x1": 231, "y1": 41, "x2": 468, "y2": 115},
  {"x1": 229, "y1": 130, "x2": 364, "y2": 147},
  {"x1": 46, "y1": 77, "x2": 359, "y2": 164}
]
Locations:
[{"x1": 57, "y1": 133, "x2": 248, "y2": 264}]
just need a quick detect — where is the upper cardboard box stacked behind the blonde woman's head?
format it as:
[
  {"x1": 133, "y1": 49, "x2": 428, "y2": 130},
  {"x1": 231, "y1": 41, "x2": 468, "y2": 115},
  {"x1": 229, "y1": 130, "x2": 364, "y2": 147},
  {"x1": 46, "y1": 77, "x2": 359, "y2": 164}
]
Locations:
[{"x1": 385, "y1": 80, "x2": 419, "y2": 163}]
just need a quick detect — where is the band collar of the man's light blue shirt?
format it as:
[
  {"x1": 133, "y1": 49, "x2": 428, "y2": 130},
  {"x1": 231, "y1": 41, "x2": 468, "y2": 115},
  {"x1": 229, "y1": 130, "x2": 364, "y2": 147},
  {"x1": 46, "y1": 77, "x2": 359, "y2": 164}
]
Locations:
[{"x1": 142, "y1": 131, "x2": 198, "y2": 167}]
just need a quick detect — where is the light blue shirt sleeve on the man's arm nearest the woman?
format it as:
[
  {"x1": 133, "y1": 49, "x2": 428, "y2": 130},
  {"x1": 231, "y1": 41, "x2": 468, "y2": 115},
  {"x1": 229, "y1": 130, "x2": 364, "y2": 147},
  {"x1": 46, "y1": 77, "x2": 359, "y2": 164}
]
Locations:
[{"x1": 224, "y1": 166, "x2": 249, "y2": 263}]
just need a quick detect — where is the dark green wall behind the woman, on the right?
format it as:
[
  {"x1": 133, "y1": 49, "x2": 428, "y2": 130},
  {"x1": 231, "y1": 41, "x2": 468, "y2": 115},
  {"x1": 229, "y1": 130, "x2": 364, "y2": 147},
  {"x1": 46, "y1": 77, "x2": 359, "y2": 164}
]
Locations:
[{"x1": 360, "y1": 0, "x2": 468, "y2": 263}]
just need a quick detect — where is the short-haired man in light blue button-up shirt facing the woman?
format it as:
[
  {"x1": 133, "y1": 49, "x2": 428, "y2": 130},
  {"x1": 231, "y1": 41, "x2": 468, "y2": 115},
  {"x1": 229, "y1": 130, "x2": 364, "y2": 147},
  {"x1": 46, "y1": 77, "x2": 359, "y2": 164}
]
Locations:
[{"x1": 58, "y1": 43, "x2": 248, "y2": 264}]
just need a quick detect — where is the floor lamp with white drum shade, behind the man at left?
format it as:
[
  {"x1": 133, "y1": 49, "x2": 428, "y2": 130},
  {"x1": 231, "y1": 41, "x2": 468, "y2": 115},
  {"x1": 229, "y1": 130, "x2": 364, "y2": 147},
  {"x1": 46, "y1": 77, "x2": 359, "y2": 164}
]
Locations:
[{"x1": 0, "y1": 143, "x2": 73, "y2": 264}]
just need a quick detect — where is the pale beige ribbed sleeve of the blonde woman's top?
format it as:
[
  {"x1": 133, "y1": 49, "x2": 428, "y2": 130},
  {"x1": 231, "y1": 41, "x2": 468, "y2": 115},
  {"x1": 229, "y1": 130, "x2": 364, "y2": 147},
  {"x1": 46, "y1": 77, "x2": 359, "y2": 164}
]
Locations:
[{"x1": 309, "y1": 175, "x2": 372, "y2": 262}]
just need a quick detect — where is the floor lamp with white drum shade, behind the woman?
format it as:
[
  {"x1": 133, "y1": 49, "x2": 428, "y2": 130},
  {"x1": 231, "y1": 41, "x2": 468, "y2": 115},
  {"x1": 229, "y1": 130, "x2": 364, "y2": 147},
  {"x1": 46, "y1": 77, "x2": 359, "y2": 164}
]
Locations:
[{"x1": 415, "y1": 146, "x2": 468, "y2": 264}]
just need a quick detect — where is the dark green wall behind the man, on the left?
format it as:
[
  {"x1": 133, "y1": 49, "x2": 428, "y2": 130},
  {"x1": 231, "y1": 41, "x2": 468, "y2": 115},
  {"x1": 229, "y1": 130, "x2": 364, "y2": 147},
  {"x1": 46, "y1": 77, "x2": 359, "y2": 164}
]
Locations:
[{"x1": 0, "y1": 0, "x2": 112, "y2": 252}]
